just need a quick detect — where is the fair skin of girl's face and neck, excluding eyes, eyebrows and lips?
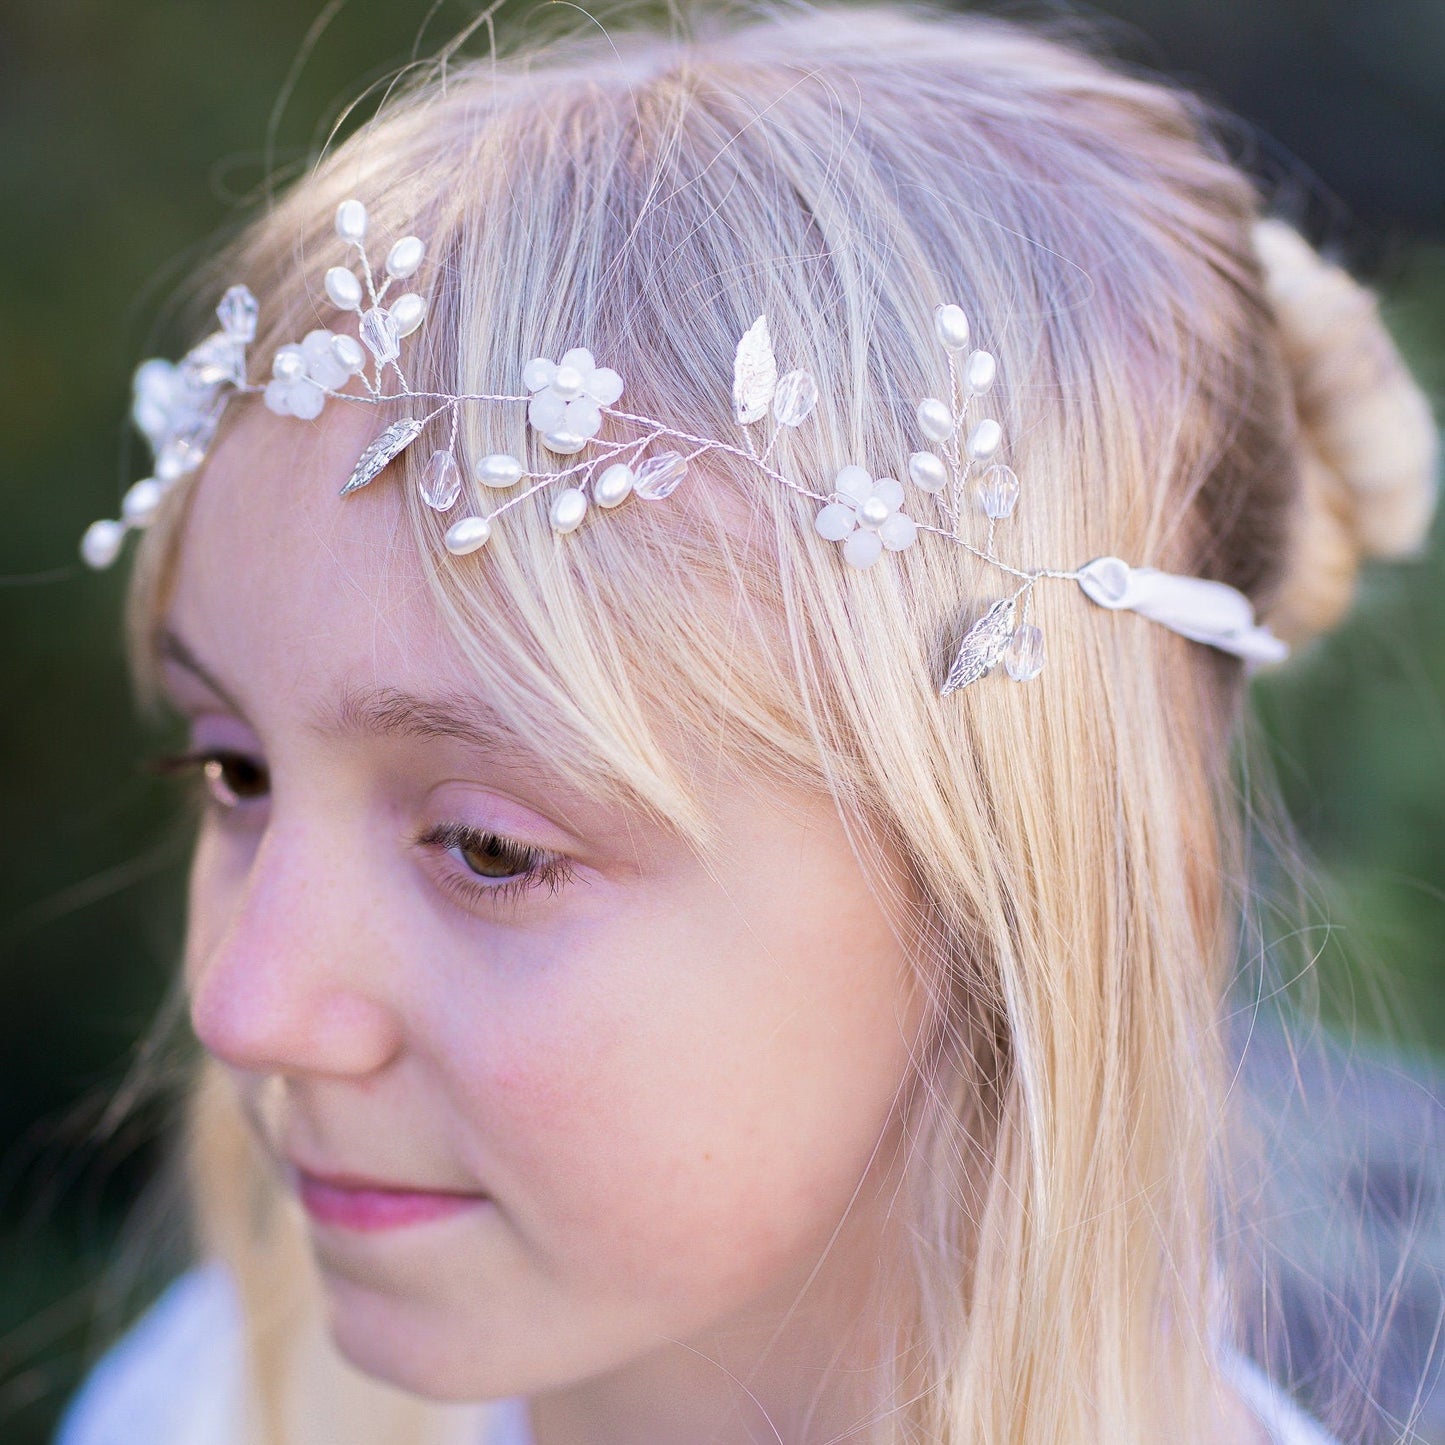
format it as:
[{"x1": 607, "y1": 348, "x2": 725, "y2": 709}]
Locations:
[{"x1": 168, "y1": 403, "x2": 920, "y2": 1445}]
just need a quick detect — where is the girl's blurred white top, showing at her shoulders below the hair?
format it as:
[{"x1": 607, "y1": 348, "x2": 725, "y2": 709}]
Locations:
[{"x1": 55, "y1": 1261, "x2": 1340, "y2": 1445}]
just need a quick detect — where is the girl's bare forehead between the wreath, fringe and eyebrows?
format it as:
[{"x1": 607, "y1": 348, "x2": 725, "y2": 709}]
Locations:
[{"x1": 166, "y1": 402, "x2": 455, "y2": 713}]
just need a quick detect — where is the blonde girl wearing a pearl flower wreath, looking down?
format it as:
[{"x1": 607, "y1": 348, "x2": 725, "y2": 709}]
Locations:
[{"x1": 61, "y1": 9, "x2": 1433, "y2": 1445}]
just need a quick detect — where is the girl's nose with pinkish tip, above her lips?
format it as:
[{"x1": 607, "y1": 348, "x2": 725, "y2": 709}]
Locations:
[{"x1": 186, "y1": 821, "x2": 403, "y2": 1078}]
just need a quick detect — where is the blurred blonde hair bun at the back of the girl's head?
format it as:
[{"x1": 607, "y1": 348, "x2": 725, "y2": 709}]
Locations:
[{"x1": 1254, "y1": 220, "x2": 1438, "y2": 644}]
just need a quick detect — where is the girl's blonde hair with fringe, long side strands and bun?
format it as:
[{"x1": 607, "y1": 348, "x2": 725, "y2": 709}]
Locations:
[{"x1": 104, "y1": 7, "x2": 1433, "y2": 1445}]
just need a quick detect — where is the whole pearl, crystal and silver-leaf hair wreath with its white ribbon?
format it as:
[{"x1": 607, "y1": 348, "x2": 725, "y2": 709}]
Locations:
[{"x1": 81, "y1": 199, "x2": 1289, "y2": 694}]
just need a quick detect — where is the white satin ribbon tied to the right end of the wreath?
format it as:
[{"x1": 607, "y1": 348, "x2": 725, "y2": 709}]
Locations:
[{"x1": 1075, "y1": 556, "x2": 1289, "y2": 665}]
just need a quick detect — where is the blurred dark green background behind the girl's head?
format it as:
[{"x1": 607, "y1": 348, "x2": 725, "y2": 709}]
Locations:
[{"x1": 0, "y1": 0, "x2": 1445, "y2": 1445}]
